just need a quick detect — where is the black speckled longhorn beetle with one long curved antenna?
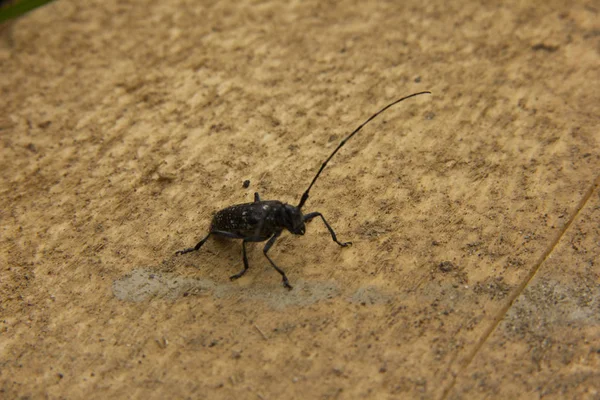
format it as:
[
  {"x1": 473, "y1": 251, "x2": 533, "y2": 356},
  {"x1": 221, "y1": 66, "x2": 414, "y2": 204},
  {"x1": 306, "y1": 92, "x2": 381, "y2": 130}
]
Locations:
[{"x1": 175, "y1": 91, "x2": 431, "y2": 289}]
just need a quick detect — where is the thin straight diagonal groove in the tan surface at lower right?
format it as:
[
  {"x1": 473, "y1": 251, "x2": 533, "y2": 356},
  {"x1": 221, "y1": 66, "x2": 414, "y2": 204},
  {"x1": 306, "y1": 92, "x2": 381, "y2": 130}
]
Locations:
[{"x1": 440, "y1": 175, "x2": 600, "y2": 400}]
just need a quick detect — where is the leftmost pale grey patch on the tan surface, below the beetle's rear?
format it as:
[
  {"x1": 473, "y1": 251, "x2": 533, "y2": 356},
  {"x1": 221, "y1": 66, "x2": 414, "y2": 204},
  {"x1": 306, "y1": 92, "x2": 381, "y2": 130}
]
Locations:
[{"x1": 112, "y1": 268, "x2": 215, "y2": 302}]
